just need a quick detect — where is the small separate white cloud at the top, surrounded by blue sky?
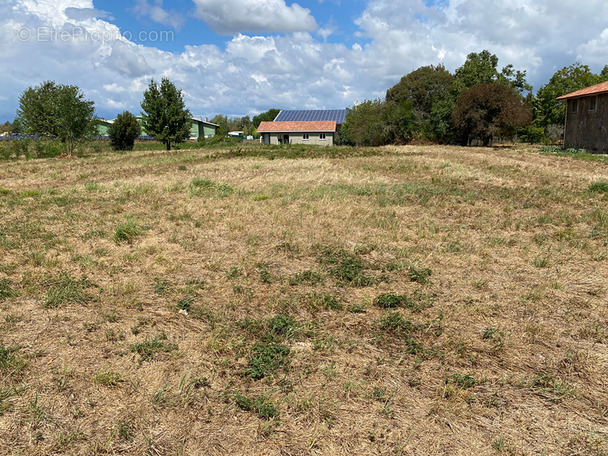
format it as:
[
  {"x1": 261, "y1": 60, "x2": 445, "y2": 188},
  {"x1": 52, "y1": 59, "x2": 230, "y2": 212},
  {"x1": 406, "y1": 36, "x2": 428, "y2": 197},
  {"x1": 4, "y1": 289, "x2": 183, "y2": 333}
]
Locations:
[{"x1": 194, "y1": 0, "x2": 318, "y2": 35}]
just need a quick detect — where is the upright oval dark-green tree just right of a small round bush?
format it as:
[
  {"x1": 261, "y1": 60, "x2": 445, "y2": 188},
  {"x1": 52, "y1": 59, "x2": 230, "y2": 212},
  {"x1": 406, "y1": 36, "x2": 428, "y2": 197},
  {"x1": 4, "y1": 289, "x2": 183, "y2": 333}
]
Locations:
[{"x1": 141, "y1": 78, "x2": 192, "y2": 150}]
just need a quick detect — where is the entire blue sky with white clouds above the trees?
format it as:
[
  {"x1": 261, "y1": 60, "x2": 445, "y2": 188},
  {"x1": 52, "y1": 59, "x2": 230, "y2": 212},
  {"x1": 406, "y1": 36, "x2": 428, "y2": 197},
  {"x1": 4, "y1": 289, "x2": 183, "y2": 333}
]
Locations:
[{"x1": 0, "y1": 0, "x2": 608, "y2": 122}]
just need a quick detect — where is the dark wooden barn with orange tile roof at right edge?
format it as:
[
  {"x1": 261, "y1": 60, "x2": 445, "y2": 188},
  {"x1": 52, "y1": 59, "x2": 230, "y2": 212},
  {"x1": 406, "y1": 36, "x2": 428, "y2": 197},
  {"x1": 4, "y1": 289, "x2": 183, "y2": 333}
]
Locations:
[{"x1": 558, "y1": 81, "x2": 608, "y2": 152}]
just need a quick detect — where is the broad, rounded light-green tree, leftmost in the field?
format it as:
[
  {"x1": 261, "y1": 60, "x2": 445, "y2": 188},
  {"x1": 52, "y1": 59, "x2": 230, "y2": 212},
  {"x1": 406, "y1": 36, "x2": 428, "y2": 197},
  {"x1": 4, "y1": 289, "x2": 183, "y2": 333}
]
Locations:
[{"x1": 16, "y1": 81, "x2": 95, "y2": 154}]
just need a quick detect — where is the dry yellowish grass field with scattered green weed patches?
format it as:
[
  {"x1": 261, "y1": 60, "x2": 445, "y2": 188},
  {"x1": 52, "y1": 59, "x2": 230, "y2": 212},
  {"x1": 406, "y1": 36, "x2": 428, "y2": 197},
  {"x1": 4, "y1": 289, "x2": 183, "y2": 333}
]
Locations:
[{"x1": 0, "y1": 146, "x2": 608, "y2": 456}]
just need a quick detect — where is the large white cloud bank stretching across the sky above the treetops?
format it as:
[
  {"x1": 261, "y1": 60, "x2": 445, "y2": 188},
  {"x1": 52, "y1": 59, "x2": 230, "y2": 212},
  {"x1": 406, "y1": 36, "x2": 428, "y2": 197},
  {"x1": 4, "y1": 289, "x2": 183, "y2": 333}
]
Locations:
[{"x1": 0, "y1": 0, "x2": 608, "y2": 122}]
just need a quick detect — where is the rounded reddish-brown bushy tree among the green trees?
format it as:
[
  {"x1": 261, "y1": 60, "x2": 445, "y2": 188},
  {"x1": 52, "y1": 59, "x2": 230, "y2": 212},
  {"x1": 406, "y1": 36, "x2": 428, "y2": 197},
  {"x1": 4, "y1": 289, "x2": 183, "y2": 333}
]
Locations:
[{"x1": 452, "y1": 82, "x2": 532, "y2": 146}]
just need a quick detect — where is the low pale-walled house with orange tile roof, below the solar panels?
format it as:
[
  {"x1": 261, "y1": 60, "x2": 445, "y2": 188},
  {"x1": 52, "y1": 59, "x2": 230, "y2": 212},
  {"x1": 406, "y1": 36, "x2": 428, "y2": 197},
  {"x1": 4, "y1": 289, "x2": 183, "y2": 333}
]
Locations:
[{"x1": 258, "y1": 120, "x2": 338, "y2": 146}]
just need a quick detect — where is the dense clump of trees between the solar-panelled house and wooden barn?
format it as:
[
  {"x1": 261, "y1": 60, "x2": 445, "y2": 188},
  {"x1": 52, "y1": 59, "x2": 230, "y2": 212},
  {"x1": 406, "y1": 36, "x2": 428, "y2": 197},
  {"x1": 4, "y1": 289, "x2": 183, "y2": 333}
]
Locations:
[{"x1": 339, "y1": 51, "x2": 608, "y2": 146}]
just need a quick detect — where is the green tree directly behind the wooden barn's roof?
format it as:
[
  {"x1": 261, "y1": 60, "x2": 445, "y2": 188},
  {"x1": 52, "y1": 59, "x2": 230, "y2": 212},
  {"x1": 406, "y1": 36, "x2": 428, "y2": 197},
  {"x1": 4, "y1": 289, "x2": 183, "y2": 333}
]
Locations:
[{"x1": 533, "y1": 62, "x2": 608, "y2": 128}]
